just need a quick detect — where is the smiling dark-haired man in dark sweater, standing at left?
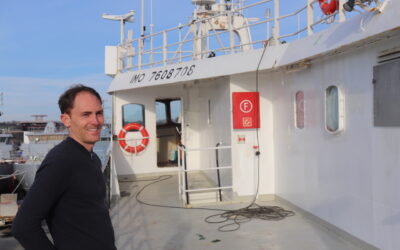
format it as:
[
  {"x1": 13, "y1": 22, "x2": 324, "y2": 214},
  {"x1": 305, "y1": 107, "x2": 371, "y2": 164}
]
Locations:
[{"x1": 12, "y1": 85, "x2": 116, "y2": 250}]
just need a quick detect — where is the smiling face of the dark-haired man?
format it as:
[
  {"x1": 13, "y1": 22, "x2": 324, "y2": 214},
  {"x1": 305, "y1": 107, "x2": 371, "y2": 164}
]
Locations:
[{"x1": 61, "y1": 92, "x2": 104, "y2": 151}]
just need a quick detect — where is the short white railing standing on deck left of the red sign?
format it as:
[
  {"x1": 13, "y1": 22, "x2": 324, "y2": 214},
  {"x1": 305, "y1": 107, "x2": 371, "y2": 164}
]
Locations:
[{"x1": 178, "y1": 142, "x2": 232, "y2": 206}]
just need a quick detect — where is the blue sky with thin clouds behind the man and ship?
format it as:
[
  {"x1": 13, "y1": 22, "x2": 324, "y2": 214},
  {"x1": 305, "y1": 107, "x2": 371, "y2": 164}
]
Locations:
[{"x1": 0, "y1": 0, "x2": 332, "y2": 122}]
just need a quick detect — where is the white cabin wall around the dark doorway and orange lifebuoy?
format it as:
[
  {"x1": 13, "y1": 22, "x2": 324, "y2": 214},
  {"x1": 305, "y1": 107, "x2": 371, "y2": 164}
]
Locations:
[{"x1": 114, "y1": 78, "x2": 231, "y2": 178}]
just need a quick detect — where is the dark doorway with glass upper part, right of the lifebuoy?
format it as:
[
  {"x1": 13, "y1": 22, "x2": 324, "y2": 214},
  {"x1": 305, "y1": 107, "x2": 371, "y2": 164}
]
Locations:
[{"x1": 156, "y1": 99, "x2": 182, "y2": 168}]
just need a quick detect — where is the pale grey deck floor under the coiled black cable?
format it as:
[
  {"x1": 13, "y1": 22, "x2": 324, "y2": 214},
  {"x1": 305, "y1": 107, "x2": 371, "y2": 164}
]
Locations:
[{"x1": 111, "y1": 176, "x2": 368, "y2": 250}]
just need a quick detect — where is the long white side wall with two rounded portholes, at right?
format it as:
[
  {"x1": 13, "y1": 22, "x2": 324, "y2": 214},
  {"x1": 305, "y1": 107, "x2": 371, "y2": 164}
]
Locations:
[{"x1": 268, "y1": 38, "x2": 400, "y2": 250}]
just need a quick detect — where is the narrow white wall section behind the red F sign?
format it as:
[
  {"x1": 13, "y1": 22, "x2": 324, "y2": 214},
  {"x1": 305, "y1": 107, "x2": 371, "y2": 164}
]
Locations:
[{"x1": 230, "y1": 72, "x2": 275, "y2": 196}]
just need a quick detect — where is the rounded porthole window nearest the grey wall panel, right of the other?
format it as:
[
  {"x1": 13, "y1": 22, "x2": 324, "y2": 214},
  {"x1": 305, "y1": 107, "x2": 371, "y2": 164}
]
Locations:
[{"x1": 325, "y1": 85, "x2": 344, "y2": 133}]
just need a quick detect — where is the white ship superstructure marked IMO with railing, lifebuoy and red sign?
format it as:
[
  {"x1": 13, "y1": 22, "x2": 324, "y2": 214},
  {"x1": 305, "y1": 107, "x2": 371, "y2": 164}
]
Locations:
[{"x1": 106, "y1": 0, "x2": 400, "y2": 250}]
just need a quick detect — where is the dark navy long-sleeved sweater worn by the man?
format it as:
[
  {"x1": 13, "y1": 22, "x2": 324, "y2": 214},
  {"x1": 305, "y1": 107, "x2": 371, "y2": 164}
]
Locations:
[{"x1": 12, "y1": 137, "x2": 116, "y2": 250}]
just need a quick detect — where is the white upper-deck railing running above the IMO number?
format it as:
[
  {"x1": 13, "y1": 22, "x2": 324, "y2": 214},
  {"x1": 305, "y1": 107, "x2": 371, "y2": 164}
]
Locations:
[{"x1": 119, "y1": 0, "x2": 378, "y2": 72}]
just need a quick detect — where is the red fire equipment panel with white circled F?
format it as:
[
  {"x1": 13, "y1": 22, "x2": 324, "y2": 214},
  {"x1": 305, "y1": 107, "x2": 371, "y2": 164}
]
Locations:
[{"x1": 232, "y1": 92, "x2": 260, "y2": 129}]
